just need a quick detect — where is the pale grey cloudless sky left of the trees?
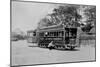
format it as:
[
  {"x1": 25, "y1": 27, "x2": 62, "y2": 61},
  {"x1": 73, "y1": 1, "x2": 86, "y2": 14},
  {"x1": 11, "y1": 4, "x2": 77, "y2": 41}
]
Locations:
[{"x1": 11, "y1": 1, "x2": 57, "y2": 32}]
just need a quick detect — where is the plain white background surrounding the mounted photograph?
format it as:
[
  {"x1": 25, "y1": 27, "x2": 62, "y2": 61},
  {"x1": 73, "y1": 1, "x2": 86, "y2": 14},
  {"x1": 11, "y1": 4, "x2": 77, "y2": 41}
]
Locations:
[{"x1": 0, "y1": 0, "x2": 100, "y2": 67}]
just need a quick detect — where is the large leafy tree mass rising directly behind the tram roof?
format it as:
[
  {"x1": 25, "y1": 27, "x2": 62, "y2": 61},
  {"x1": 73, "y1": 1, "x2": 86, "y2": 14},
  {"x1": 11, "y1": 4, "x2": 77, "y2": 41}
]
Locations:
[{"x1": 39, "y1": 6, "x2": 81, "y2": 27}]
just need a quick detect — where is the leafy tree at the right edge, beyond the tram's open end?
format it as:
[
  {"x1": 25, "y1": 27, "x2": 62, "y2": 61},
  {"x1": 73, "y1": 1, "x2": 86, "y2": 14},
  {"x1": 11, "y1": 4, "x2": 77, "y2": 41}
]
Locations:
[{"x1": 82, "y1": 6, "x2": 96, "y2": 32}]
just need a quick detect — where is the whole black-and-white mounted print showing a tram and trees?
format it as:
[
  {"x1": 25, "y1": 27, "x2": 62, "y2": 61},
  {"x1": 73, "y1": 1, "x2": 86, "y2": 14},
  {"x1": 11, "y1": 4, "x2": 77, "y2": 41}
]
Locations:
[{"x1": 10, "y1": 0, "x2": 96, "y2": 66}]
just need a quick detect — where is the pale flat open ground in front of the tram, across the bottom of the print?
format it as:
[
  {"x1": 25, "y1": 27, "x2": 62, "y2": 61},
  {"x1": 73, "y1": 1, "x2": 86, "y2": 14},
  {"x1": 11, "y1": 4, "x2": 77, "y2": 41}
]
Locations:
[{"x1": 11, "y1": 41, "x2": 95, "y2": 65}]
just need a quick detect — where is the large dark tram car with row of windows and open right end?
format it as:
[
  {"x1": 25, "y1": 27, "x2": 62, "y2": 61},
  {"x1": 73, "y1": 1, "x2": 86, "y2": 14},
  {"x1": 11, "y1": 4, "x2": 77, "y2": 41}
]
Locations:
[{"x1": 37, "y1": 25, "x2": 79, "y2": 49}]
